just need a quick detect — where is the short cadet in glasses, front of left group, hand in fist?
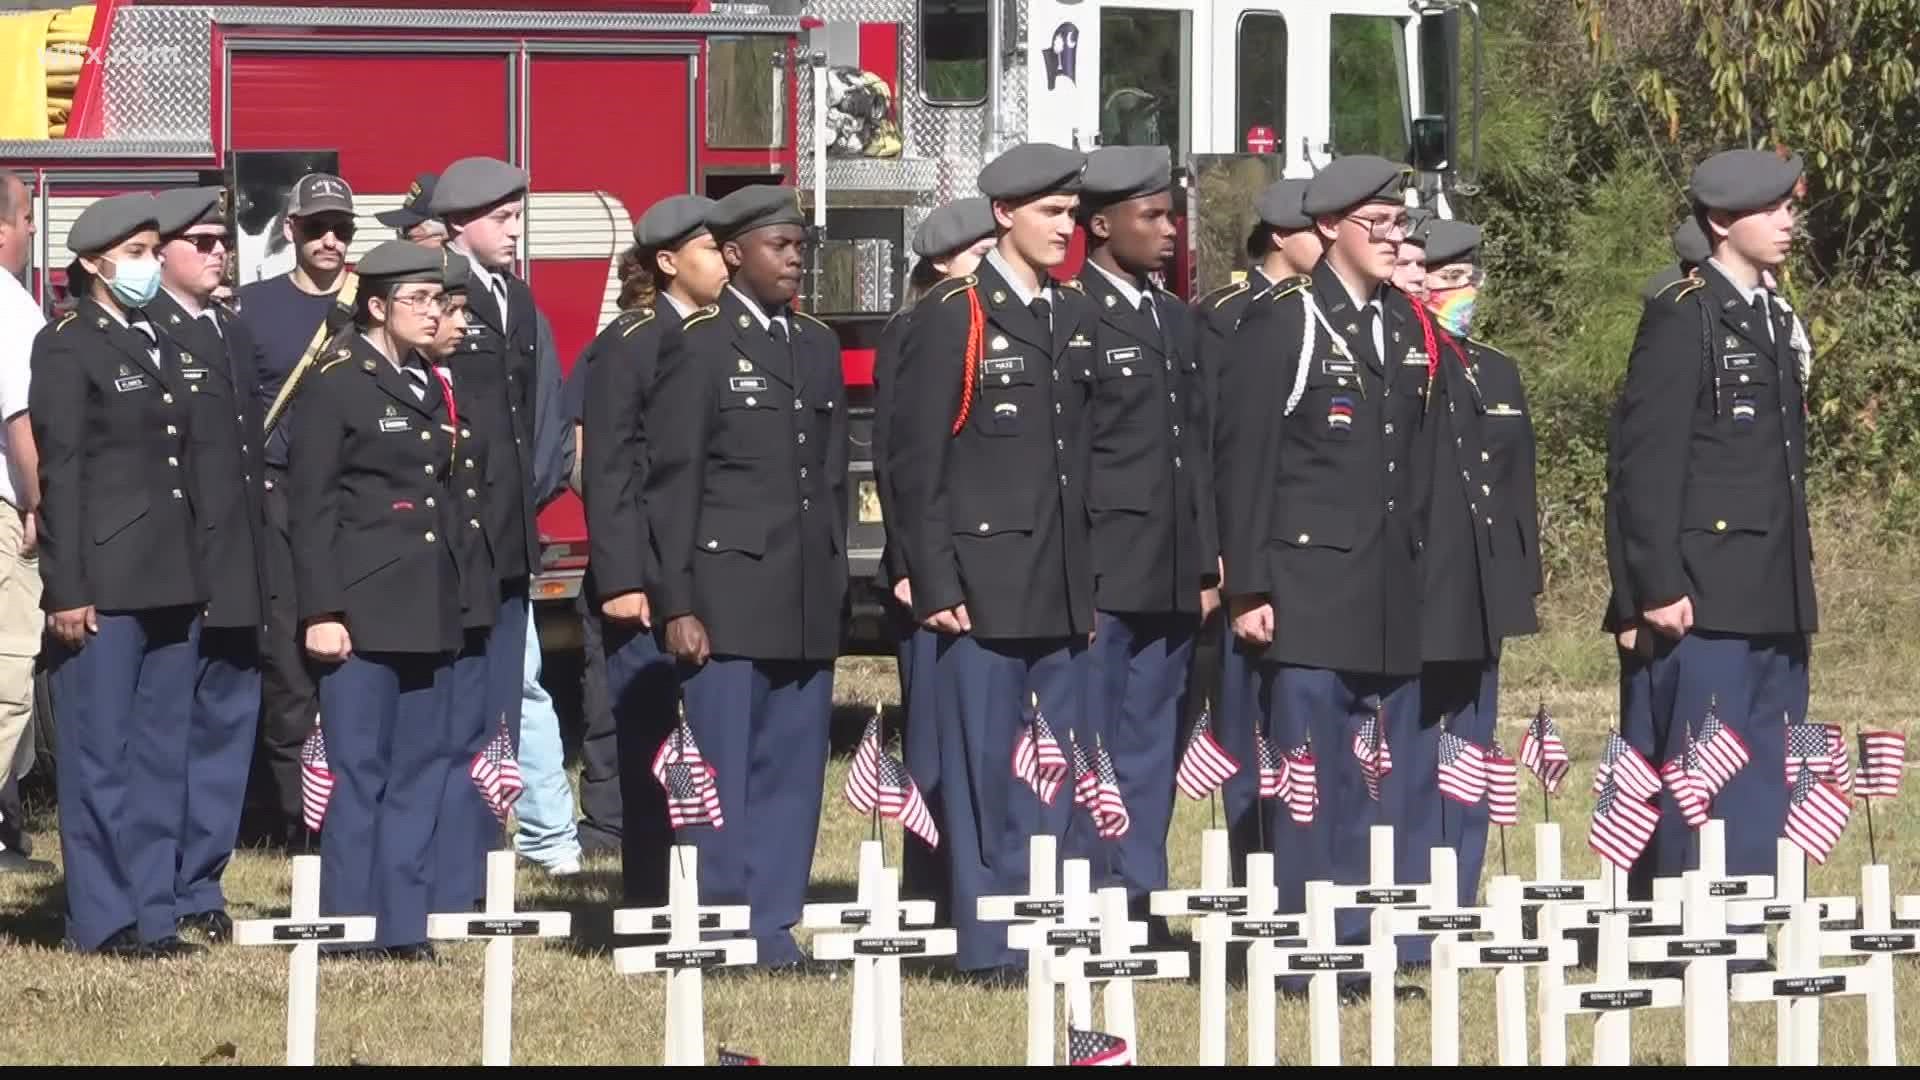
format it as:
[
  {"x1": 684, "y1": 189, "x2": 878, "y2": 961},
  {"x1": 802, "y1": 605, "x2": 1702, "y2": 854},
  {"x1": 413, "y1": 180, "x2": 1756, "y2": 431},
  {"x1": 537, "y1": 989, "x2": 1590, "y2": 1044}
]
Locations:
[{"x1": 288, "y1": 240, "x2": 467, "y2": 959}]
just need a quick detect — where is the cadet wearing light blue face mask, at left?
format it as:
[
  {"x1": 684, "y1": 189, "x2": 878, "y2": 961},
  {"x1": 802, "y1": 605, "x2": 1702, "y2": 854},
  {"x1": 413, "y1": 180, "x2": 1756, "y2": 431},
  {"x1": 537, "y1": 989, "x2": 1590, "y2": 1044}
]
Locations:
[{"x1": 27, "y1": 194, "x2": 207, "y2": 955}]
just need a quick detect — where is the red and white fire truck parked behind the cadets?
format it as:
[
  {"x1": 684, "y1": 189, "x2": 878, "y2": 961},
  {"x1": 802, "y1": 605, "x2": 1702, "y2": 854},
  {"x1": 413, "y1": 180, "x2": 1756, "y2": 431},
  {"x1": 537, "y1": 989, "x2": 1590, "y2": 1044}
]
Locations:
[{"x1": 0, "y1": 0, "x2": 1478, "y2": 651}]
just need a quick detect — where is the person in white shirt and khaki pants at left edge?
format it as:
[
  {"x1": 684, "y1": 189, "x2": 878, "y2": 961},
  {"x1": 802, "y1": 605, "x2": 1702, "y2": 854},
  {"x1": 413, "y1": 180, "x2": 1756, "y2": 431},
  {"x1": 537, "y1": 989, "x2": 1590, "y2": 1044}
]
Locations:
[{"x1": 0, "y1": 171, "x2": 52, "y2": 872}]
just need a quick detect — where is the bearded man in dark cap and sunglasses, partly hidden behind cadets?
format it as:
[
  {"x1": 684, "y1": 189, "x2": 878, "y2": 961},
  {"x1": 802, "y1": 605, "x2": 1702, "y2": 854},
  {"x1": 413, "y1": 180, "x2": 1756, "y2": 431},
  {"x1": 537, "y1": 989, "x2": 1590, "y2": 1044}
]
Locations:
[{"x1": 238, "y1": 173, "x2": 353, "y2": 844}]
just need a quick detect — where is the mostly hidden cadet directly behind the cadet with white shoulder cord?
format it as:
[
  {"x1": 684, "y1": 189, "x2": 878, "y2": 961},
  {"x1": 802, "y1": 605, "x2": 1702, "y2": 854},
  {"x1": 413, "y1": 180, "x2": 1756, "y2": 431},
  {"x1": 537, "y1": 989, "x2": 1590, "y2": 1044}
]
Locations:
[{"x1": 1194, "y1": 181, "x2": 1327, "y2": 883}]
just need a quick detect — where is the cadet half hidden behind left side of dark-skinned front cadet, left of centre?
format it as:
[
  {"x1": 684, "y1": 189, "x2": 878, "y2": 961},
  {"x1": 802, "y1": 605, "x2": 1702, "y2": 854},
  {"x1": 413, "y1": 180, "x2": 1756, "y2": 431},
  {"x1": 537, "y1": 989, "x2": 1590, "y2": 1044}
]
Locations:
[{"x1": 580, "y1": 194, "x2": 728, "y2": 905}]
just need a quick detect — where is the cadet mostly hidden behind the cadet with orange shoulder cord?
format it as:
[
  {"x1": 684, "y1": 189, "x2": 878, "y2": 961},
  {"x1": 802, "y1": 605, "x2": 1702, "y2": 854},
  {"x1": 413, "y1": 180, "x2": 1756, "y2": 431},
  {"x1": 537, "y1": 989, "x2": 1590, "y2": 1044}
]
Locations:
[{"x1": 874, "y1": 196, "x2": 995, "y2": 907}]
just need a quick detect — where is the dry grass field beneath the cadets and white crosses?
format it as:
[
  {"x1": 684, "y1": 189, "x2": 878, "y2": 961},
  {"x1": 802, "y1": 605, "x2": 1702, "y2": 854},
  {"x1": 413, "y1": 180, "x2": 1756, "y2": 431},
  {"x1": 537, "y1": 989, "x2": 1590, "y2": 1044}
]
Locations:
[{"x1": 0, "y1": 515, "x2": 1920, "y2": 1065}]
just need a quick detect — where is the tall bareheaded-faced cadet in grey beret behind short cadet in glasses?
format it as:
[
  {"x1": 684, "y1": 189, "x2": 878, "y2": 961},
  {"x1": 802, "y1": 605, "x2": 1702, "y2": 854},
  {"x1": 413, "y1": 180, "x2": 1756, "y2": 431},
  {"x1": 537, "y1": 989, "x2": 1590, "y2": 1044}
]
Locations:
[{"x1": 428, "y1": 158, "x2": 541, "y2": 745}]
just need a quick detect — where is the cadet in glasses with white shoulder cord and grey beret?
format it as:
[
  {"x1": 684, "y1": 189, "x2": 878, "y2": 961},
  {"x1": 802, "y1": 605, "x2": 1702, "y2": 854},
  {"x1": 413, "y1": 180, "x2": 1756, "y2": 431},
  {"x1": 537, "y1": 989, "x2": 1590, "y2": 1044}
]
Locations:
[{"x1": 1215, "y1": 156, "x2": 1427, "y2": 942}]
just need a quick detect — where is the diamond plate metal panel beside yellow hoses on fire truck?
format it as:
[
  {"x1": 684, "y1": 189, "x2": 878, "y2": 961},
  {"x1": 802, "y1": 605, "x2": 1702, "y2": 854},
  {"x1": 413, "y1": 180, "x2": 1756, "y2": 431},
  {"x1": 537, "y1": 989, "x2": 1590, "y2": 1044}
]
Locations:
[{"x1": 100, "y1": 8, "x2": 213, "y2": 140}]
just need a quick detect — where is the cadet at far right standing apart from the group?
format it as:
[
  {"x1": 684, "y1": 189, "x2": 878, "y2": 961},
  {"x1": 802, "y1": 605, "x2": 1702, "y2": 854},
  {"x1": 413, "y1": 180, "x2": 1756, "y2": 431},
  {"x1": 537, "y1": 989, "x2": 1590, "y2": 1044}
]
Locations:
[{"x1": 1609, "y1": 150, "x2": 1818, "y2": 890}]
